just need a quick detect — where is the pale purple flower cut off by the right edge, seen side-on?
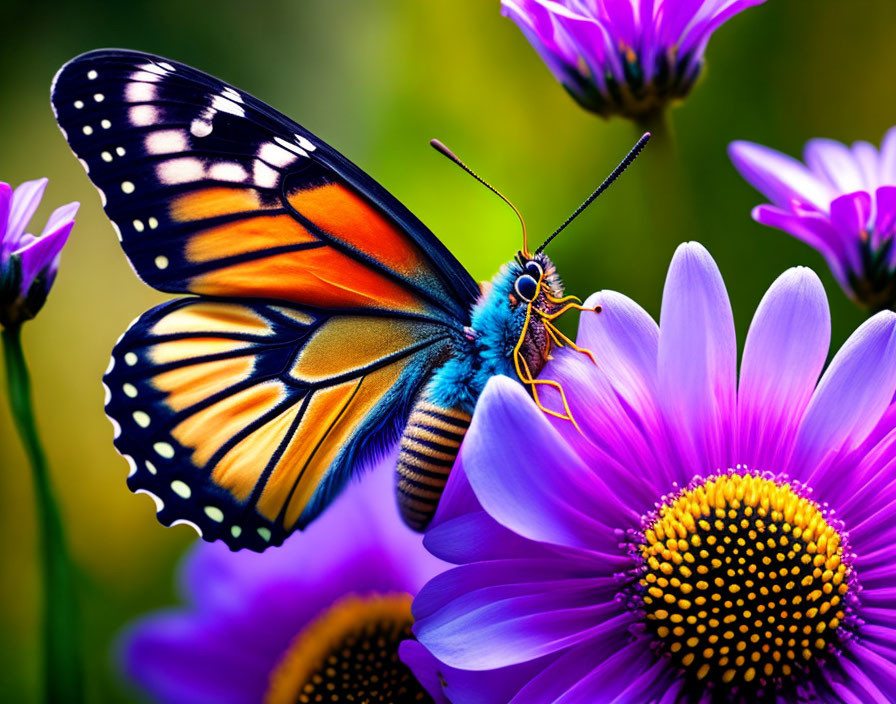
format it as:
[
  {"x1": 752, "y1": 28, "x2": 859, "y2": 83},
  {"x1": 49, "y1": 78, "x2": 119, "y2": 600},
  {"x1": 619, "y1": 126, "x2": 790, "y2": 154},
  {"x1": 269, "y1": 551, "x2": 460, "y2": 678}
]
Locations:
[{"x1": 728, "y1": 127, "x2": 896, "y2": 311}]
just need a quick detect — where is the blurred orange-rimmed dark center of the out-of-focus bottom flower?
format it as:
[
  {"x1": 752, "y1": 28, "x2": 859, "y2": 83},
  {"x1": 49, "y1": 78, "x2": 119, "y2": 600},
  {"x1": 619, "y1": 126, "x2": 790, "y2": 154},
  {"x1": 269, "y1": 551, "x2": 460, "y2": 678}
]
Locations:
[{"x1": 265, "y1": 594, "x2": 432, "y2": 704}]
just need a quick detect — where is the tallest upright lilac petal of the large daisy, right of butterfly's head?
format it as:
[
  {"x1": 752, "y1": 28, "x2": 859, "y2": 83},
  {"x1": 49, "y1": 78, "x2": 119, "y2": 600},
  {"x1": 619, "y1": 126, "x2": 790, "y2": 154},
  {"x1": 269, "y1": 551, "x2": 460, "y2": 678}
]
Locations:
[{"x1": 659, "y1": 242, "x2": 737, "y2": 472}]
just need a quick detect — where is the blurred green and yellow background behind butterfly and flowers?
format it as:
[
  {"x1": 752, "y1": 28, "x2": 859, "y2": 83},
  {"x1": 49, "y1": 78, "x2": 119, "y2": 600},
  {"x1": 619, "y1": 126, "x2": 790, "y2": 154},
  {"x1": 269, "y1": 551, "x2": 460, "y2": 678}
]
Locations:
[{"x1": 0, "y1": 0, "x2": 896, "y2": 702}]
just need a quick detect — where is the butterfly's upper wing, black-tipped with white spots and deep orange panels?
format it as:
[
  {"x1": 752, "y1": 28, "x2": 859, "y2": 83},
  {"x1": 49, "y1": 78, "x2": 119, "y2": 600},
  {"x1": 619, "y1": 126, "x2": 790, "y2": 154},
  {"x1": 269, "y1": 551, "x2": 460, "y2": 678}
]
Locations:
[{"x1": 52, "y1": 50, "x2": 478, "y2": 326}]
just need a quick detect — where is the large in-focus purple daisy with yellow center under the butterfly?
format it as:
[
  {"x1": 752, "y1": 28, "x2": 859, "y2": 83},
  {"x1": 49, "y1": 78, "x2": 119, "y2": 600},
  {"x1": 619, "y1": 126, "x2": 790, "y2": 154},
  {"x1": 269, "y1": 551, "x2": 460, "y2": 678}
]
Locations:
[{"x1": 410, "y1": 244, "x2": 896, "y2": 704}]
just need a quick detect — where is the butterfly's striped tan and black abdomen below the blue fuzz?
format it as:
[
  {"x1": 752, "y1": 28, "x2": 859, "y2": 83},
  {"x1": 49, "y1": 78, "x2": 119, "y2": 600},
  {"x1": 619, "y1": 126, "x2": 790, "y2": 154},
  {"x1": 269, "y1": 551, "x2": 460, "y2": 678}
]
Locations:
[{"x1": 395, "y1": 400, "x2": 470, "y2": 531}]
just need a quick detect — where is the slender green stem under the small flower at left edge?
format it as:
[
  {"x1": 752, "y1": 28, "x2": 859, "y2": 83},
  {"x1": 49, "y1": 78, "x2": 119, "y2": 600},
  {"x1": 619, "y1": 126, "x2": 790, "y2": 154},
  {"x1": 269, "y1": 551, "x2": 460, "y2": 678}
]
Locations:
[{"x1": 2, "y1": 325, "x2": 84, "y2": 704}]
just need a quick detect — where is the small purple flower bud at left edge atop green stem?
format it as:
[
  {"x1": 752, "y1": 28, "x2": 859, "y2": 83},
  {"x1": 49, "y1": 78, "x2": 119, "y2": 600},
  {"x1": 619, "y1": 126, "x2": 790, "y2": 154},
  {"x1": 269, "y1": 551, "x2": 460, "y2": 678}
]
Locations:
[{"x1": 0, "y1": 178, "x2": 78, "y2": 327}]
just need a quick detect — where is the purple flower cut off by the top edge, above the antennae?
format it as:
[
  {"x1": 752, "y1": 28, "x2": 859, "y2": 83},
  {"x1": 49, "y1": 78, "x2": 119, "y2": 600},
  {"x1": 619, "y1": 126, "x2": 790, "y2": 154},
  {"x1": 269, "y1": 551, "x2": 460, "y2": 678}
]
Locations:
[{"x1": 501, "y1": 0, "x2": 765, "y2": 120}]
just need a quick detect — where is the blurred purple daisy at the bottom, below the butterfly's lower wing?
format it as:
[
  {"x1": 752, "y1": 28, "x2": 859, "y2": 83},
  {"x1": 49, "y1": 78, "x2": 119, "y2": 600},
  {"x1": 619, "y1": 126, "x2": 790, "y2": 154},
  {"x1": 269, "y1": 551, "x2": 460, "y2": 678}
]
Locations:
[{"x1": 120, "y1": 466, "x2": 445, "y2": 704}]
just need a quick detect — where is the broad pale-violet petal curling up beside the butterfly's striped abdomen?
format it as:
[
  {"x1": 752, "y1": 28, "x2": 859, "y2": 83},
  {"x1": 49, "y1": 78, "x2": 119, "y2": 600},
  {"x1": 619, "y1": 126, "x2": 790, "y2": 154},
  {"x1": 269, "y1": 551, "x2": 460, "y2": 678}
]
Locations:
[{"x1": 461, "y1": 377, "x2": 630, "y2": 553}]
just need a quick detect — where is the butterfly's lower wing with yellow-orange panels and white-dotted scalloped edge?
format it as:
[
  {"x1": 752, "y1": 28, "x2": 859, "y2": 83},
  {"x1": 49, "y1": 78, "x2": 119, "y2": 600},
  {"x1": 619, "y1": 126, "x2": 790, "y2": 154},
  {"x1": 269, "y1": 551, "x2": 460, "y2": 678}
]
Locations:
[{"x1": 104, "y1": 298, "x2": 450, "y2": 550}]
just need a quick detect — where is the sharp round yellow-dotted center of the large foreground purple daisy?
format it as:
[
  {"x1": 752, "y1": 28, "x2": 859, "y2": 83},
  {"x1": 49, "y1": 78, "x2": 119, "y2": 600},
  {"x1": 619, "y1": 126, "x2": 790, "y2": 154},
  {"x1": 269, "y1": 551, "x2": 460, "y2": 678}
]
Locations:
[{"x1": 639, "y1": 473, "x2": 851, "y2": 688}]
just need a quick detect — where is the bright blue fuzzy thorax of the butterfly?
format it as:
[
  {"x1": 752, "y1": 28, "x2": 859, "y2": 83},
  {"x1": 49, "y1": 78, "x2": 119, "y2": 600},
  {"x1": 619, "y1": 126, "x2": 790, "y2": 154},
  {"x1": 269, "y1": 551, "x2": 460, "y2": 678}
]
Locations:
[{"x1": 427, "y1": 261, "x2": 526, "y2": 414}]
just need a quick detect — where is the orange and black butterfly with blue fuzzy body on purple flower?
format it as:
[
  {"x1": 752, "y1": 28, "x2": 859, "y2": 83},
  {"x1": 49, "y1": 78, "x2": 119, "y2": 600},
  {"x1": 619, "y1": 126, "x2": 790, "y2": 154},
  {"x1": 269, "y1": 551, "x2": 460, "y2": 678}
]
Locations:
[{"x1": 51, "y1": 50, "x2": 647, "y2": 551}]
